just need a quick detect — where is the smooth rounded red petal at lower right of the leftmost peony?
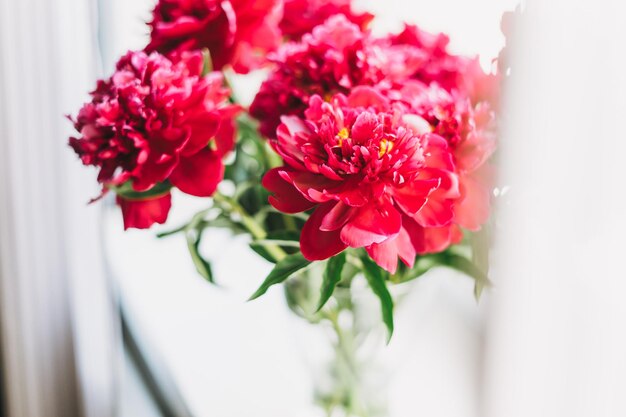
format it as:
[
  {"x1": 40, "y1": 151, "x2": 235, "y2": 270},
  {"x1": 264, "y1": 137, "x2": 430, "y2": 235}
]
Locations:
[{"x1": 170, "y1": 148, "x2": 224, "y2": 197}]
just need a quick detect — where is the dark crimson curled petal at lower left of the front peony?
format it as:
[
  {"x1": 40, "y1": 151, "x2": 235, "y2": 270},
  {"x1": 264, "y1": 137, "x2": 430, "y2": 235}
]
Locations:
[{"x1": 300, "y1": 203, "x2": 347, "y2": 261}]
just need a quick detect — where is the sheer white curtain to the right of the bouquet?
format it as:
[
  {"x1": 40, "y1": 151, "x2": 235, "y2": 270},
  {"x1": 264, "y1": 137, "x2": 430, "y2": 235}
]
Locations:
[{"x1": 483, "y1": 0, "x2": 626, "y2": 417}]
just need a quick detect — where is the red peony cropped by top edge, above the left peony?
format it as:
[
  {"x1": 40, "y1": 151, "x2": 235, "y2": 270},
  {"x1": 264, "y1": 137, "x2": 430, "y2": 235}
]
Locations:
[{"x1": 146, "y1": 0, "x2": 282, "y2": 73}]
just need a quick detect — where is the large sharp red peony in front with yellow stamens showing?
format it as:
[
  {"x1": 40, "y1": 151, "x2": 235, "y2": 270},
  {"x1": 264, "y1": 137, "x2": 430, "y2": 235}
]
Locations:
[{"x1": 263, "y1": 87, "x2": 459, "y2": 273}]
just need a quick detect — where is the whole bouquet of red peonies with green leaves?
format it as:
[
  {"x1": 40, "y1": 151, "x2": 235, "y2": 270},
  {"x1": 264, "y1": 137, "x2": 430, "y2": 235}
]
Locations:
[{"x1": 70, "y1": 0, "x2": 500, "y2": 334}]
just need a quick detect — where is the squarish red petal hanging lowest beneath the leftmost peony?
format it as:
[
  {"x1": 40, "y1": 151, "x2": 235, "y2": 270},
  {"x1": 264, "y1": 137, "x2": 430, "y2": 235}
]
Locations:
[{"x1": 116, "y1": 193, "x2": 172, "y2": 230}]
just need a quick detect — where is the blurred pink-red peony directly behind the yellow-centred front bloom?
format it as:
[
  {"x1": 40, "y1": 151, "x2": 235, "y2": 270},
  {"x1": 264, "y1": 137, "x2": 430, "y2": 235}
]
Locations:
[{"x1": 250, "y1": 15, "x2": 384, "y2": 138}]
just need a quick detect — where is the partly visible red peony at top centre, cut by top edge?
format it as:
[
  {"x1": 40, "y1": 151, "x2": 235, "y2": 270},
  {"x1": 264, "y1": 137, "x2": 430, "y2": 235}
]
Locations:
[{"x1": 280, "y1": 0, "x2": 374, "y2": 40}]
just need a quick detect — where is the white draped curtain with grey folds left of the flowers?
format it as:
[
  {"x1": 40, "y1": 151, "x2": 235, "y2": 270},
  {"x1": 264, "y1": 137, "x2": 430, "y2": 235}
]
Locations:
[{"x1": 0, "y1": 0, "x2": 118, "y2": 417}]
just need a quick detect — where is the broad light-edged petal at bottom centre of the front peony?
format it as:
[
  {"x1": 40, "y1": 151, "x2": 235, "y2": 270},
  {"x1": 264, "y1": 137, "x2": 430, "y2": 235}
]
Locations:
[{"x1": 341, "y1": 200, "x2": 402, "y2": 248}]
